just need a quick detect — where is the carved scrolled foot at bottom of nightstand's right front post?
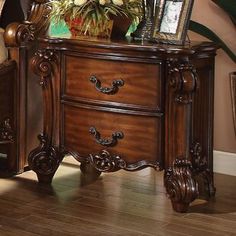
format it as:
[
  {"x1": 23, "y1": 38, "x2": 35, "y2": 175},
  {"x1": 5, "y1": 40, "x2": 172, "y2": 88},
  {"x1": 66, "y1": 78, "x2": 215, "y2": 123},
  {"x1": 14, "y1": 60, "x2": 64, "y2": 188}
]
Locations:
[{"x1": 164, "y1": 159, "x2": 198, "y2": 212}]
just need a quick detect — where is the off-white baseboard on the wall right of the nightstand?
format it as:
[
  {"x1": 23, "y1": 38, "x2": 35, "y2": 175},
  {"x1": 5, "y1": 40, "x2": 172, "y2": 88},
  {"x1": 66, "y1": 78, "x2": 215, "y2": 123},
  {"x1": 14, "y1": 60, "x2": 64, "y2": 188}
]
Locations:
[{"x1": 213, "y1": 150, "x2": 236, "y2": 176}]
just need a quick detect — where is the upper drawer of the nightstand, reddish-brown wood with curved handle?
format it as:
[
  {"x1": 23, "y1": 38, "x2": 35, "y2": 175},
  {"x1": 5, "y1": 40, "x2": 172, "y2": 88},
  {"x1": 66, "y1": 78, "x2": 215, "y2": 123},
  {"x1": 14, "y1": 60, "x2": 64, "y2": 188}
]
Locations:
[{"x1": 62, "y1": 55, "x2": 161, "y2": 110}]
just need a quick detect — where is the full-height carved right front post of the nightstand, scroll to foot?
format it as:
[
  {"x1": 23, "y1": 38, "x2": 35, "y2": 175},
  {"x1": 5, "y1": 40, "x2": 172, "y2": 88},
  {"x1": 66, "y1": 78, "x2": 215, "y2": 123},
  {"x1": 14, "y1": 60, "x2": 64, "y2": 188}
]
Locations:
[{"x1": 164, "y1": 59, "x2": 198, "y2": 212}]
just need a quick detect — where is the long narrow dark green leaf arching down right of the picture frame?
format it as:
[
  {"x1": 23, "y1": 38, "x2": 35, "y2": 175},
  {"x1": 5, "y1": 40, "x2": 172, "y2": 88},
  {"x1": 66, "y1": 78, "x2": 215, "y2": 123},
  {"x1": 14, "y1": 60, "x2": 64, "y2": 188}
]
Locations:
[{"x1": 189, "y1": 20, "x2": 236, "y2": 63}]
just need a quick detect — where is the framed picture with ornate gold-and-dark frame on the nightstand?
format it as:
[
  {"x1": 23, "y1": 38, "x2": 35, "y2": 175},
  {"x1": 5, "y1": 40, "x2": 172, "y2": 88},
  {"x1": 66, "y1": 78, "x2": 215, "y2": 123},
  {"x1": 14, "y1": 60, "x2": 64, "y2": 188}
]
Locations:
[{"x1": 153, "y1": 0, "x2": 193, "y2": 45}]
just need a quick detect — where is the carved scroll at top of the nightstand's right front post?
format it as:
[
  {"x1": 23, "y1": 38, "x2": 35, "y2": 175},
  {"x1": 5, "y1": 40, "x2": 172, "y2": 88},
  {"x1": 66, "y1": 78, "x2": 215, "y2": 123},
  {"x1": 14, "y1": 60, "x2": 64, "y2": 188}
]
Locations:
[{"x1": 168, "y1": 61, "x2": 199, "y2": 104}]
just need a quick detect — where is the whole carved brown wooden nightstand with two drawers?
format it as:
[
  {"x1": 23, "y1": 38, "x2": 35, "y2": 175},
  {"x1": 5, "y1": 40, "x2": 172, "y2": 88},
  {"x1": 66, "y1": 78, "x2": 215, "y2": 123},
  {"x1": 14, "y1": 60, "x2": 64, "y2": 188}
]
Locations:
[{"x1": 28, "y1": 38, "x2": 217, "y2": 212}]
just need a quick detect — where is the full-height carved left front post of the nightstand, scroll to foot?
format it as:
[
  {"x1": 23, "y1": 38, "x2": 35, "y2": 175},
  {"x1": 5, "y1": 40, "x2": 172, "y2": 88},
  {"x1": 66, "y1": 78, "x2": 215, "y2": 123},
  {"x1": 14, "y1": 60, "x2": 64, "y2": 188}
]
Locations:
[{"x1": 28, "y1": 50, "x2": 62, "y2": 183}]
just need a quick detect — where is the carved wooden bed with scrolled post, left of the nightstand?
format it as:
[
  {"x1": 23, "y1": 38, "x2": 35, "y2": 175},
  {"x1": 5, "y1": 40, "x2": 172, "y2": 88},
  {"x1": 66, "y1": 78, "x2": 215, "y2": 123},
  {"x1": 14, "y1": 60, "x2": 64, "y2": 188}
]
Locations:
[{"x1": 0, "y1": 0, "x2": 49, "y2": 175}]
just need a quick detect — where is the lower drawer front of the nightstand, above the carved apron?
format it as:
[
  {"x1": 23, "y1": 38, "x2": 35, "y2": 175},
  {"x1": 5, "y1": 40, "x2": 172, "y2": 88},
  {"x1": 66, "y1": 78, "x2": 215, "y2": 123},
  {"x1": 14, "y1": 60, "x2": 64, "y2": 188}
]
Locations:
[{"x1": 62, "y1": 105, "x2": 161, "y2": 163}]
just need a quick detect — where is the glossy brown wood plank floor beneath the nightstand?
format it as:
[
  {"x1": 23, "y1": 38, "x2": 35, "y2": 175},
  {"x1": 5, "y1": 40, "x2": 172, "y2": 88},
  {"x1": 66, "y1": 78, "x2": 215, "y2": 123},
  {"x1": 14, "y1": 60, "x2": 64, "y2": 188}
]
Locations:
[{"x1": 0, "y1": 158, "x2": 236, "y2": 236}]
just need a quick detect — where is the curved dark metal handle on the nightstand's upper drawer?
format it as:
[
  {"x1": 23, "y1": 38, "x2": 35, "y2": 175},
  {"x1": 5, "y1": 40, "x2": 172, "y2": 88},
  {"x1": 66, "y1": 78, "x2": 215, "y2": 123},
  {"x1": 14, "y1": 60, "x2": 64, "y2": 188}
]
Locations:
[{"x1": 89, "y1": 75, "x2": 125, "y2": 95}]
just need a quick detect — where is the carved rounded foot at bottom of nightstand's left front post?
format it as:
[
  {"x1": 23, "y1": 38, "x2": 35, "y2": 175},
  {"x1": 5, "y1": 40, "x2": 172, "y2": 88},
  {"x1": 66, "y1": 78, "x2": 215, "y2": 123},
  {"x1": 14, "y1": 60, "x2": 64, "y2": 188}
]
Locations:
[{"x1": 28, "y1": 135, "x2": 62, "y2": 183}]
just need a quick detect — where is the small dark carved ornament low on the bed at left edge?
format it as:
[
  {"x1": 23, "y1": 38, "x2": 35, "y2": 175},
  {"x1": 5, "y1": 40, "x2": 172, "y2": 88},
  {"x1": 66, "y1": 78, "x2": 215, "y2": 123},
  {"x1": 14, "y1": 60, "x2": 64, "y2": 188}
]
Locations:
[{"x1": 0, "y1": 118, "x2": 14, "y2": 144}]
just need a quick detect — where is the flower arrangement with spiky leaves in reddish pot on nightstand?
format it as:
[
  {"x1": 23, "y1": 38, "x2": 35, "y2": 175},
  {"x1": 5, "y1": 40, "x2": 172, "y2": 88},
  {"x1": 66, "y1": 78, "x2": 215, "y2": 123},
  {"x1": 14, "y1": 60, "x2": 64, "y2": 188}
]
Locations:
[{"x1": 49, "y1": 0, "x2": 142, "y2": 37}]
